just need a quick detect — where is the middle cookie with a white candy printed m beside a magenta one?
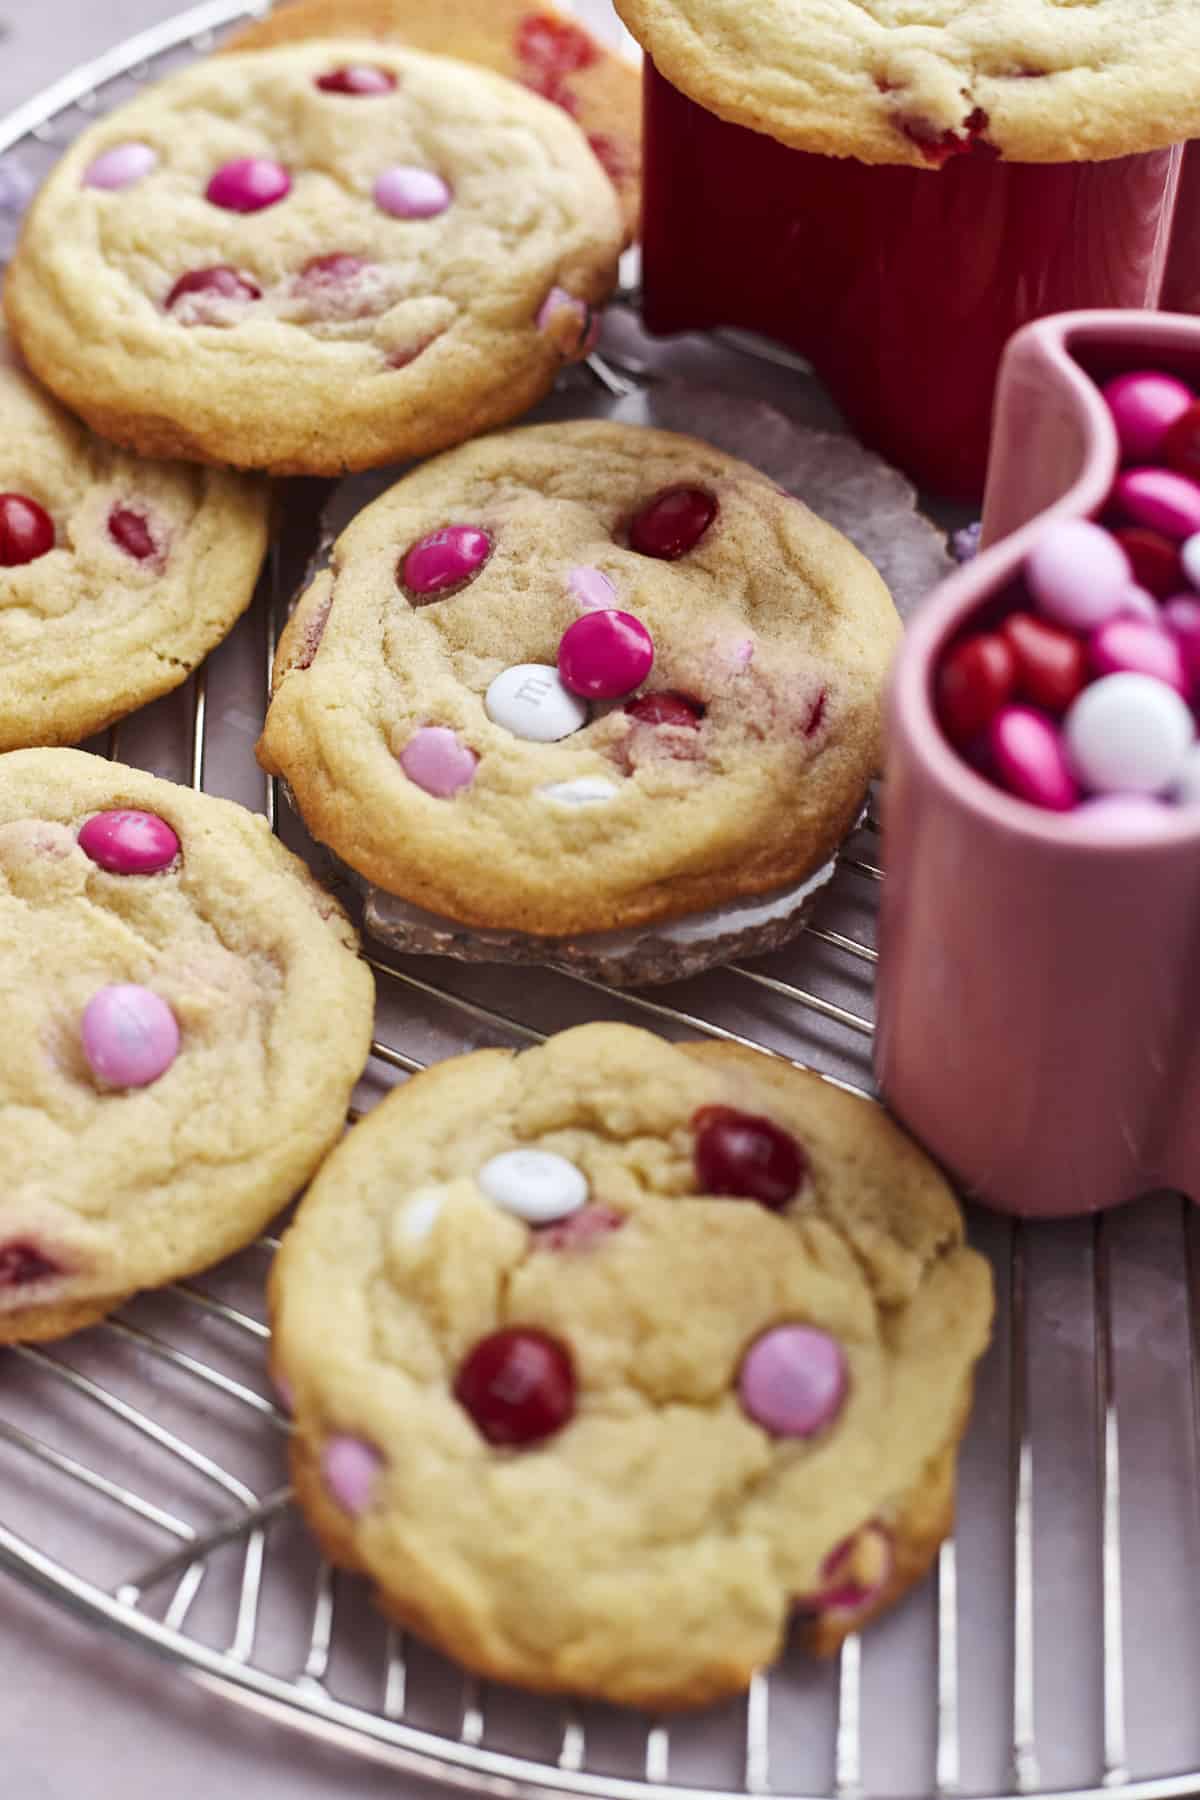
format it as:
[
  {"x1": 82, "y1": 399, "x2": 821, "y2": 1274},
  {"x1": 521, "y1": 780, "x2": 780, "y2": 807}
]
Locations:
[{"x1": 259, "y1": 421, "x2": 900, "y2": 936}]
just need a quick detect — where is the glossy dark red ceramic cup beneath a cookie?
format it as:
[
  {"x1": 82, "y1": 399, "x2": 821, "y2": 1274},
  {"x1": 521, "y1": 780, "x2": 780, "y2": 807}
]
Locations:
[{"x1": 642, "y1": 59, "x2": 1182, "y2": 500}]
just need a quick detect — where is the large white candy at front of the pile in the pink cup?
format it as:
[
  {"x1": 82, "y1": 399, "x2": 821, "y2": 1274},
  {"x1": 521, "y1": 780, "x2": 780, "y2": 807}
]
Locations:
[{"x1": 1063, "y1": 673, "x2": 1196, "y2": 794}]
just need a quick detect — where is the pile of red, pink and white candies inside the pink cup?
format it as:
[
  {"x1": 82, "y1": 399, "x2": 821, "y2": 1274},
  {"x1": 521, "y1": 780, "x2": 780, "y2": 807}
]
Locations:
[{"x1": 936, "y1": 371, "x2": 1200, "y2": 830}]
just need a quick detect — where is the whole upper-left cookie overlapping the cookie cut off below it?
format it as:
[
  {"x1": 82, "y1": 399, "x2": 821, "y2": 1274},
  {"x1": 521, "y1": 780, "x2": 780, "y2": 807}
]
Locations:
[{"x1": 5, "y1": 40, "x2": 624, "y2": 475}]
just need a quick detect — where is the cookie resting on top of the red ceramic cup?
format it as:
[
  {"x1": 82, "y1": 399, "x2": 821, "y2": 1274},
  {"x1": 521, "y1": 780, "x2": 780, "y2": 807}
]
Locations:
[{"x1": 615, "y1": 0, "x2": 1200, "y2": 167}]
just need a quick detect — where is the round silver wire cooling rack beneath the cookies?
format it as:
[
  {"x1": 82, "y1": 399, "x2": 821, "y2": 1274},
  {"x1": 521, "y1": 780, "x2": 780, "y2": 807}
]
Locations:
[{"x1": 0, "y1": 10, "x2": 1200, "y2": 1800}]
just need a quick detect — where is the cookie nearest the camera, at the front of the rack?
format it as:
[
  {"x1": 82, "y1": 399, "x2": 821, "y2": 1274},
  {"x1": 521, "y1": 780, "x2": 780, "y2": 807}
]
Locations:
[{"x1": 270, "y1": 1024, "x2": 991, "y2": 1710}]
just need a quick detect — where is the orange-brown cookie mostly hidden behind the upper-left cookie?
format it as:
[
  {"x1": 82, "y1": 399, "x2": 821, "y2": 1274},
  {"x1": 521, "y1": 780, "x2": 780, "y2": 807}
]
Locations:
[{"x1": 227, "y1": 0, "x2": 642, "y2": 238}]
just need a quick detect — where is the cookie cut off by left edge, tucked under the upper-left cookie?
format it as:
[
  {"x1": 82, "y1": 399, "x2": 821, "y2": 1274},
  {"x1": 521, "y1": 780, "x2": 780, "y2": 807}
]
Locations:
[{"x1": 0, "y1": 337, "x2": 270, "y2": 751}]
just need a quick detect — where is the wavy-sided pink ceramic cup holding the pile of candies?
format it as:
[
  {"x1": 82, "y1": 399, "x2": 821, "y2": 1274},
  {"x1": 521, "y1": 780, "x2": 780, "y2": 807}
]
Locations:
[{"x1": 876, "y1": 313, "x2": 1200, "y2": 1217}]
